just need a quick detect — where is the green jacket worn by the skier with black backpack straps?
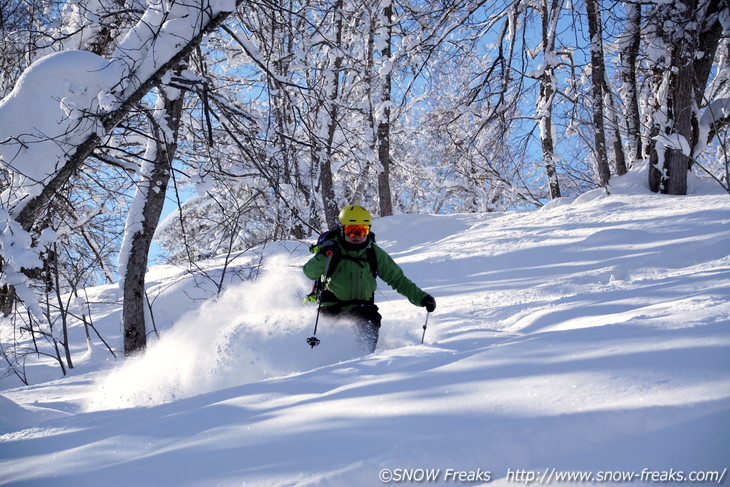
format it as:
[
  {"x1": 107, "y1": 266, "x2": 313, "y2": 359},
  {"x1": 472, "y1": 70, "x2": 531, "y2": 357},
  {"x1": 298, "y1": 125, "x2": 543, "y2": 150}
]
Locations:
[{"x1": 304, "y1": 234, "x2": 428, "y2": 311}]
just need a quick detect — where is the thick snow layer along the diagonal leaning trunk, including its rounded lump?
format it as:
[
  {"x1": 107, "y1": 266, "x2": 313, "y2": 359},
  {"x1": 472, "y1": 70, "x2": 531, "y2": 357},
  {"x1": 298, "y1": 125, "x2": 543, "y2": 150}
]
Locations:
[{"x1": 0, "y1": 0, "x2": 236, "y2": 217}]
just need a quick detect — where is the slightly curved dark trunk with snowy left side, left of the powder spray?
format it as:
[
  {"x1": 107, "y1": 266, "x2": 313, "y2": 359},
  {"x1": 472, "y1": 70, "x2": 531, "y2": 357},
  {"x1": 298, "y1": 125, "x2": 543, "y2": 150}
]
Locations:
[{"x1": 122, "y1": 86, "x2": 184, "y2": 356}]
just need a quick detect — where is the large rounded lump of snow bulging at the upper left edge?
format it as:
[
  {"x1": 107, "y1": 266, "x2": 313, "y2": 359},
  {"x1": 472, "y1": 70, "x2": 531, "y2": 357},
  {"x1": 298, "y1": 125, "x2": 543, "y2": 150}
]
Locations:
[{"x1": 0, "y1": 51, "x2": 119, "y2": 213}]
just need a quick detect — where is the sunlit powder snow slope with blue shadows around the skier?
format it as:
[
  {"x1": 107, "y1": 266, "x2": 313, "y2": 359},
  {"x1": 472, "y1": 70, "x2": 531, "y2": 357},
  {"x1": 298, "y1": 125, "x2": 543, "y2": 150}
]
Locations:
[{"x1": 0, "y1": 173, "x2": 730, "y2": 487}]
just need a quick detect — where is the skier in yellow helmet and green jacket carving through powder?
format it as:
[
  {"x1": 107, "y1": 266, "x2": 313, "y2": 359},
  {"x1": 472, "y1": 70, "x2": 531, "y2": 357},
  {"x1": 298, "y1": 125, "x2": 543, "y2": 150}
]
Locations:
[{"x1": 304, "y1": 205, "x2": 436, "y2": 352}]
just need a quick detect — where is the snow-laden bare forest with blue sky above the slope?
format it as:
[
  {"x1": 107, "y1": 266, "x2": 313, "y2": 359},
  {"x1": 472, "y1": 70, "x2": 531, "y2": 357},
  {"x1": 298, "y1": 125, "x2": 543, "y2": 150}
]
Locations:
[{"x1": 0, "y1": 0, "x2": 730, "y2": 371}]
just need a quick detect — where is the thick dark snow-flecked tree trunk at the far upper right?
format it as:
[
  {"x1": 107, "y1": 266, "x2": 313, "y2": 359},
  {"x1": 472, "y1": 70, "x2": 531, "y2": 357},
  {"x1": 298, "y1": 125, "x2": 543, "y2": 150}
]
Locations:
[{"x1": 646, "y1": 0, "x2": 730, "y2": 194}]
